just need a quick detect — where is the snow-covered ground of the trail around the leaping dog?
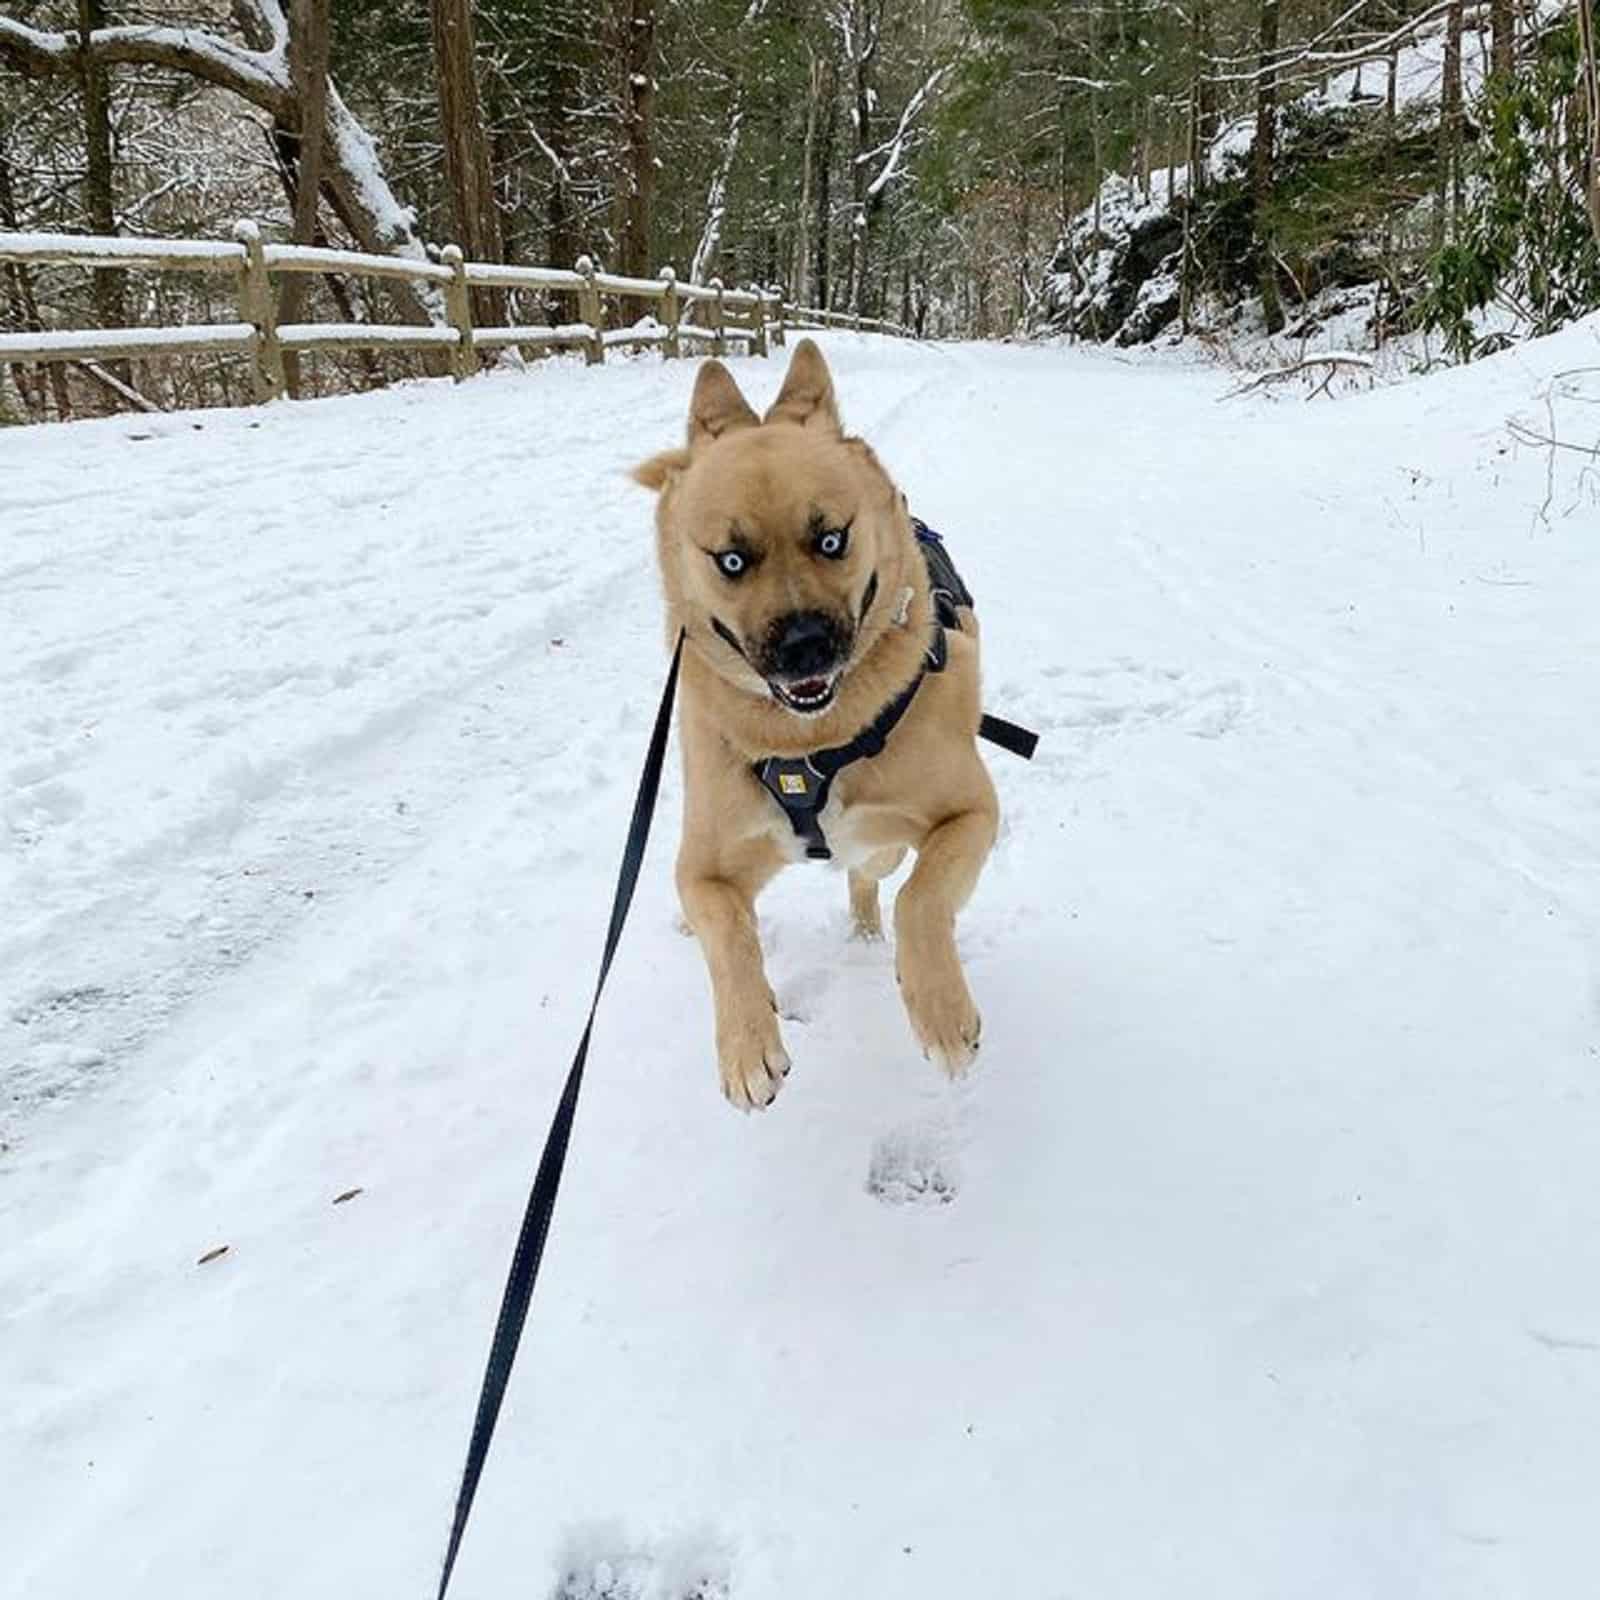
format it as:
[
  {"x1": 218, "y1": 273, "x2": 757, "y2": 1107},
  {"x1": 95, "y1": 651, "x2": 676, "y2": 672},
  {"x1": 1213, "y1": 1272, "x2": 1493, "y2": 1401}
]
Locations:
[{"x1": 0, "y1": 323, "x2": 1600, "y2": 1600}]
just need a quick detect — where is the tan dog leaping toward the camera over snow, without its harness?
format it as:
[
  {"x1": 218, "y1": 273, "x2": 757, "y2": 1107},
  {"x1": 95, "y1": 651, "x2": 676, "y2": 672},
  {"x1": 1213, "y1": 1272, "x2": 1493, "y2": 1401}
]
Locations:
[{"x1": 635, "y1": 339, "x2": 998, "y2": 1109}]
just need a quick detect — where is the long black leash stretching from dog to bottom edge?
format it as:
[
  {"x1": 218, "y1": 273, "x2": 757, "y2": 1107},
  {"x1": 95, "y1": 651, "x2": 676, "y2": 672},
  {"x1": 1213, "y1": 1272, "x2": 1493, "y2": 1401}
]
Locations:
[{"x1": 438, "y1": 632, "x2": 683, "y2": 1600}]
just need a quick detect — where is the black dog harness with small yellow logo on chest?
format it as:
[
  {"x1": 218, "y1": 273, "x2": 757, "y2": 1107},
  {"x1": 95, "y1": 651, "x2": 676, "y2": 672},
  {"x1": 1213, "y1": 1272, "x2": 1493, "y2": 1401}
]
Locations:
[{"x1": 750, "y1": 517, "x2": 1038, "y2": 861}]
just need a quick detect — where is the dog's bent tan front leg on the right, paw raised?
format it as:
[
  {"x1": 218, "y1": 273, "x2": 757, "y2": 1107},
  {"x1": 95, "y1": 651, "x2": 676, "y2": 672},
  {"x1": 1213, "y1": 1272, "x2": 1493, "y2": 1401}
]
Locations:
[{"x1": 894, "y1": 808, "x2": 997, "y2": 1075}]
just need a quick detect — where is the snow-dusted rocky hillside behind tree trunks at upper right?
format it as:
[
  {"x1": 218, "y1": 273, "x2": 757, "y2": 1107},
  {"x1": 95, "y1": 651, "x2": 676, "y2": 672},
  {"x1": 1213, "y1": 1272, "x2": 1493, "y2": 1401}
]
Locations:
[{"x1": 1038, "y1": 0, "x2": 1529, "y2": 353}]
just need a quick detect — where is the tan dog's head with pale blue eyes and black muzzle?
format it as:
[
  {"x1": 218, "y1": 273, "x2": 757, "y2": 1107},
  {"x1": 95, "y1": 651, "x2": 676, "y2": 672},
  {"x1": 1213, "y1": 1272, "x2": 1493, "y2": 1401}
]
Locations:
[{"x1": 634, "y1": 339, "x2": 910, "y2": 717}]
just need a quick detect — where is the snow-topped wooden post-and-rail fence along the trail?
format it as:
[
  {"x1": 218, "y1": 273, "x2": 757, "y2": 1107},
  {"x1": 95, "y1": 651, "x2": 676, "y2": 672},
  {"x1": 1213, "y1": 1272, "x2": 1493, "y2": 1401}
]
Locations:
[{"x1": 0, "y1": 221, "x2": 915, "y2": 400}]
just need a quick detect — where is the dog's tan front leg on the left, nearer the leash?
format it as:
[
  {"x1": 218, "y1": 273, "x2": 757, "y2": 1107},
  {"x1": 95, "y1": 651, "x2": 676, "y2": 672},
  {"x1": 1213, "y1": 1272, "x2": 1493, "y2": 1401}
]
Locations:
[{"x1": 678, "y1": 861, "x2": 789, "y2": 1110}]
